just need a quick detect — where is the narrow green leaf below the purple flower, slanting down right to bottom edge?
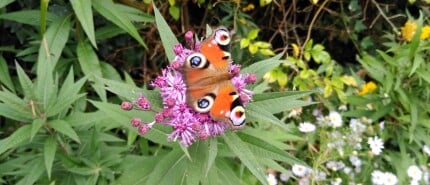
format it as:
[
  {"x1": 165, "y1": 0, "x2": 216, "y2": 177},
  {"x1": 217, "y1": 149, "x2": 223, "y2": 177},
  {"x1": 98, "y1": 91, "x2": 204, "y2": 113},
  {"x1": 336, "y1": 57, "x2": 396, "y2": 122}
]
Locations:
[{"x1": 223, "y1": 132, "x2": 268, "y2": 185}]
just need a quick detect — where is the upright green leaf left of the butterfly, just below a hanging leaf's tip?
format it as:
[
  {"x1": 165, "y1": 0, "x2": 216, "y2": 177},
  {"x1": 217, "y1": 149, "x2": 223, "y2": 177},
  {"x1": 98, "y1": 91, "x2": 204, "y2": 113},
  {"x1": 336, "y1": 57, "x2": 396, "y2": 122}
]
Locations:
[{"x1": 77, "y1": 42, "x2": 107, "y2": 101}]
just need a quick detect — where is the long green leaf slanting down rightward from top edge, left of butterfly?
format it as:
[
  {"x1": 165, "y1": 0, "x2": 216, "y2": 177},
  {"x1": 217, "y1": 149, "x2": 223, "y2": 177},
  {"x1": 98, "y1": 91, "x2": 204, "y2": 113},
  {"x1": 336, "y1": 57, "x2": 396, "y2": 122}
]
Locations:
[{"x1": 92, "y1": 0, "x2": 148, "y2": 49}]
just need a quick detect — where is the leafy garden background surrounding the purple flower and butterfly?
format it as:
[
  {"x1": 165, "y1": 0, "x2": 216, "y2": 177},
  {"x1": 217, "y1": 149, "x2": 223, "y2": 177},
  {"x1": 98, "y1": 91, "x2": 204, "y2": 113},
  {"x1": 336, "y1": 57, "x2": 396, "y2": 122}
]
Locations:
[{"x1": 0, "y1": 0, "x2": 430, "y2": 184}]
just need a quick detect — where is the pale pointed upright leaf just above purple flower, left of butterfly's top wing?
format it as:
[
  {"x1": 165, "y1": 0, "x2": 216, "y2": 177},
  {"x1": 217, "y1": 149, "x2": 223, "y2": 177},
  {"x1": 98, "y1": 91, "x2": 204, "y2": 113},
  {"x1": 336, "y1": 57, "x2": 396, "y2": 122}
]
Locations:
[{"x1": 153, "y1": 3, "x2": 179, "y2": 62}]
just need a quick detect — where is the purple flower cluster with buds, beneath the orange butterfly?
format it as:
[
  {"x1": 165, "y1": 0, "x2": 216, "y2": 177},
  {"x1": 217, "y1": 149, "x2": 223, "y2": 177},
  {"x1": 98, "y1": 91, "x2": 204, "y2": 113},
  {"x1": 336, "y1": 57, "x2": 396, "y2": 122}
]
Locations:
[{"x1": 121, "y1": 31, "x2": 256, "y2": 146}]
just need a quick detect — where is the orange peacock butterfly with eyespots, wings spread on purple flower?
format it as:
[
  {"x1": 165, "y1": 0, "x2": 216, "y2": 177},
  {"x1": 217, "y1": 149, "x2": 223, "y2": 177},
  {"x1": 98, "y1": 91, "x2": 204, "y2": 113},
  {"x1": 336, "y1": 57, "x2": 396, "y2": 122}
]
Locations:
[{"x1": 182, "y1": 27, "x2": 245, "y2": 127}]
